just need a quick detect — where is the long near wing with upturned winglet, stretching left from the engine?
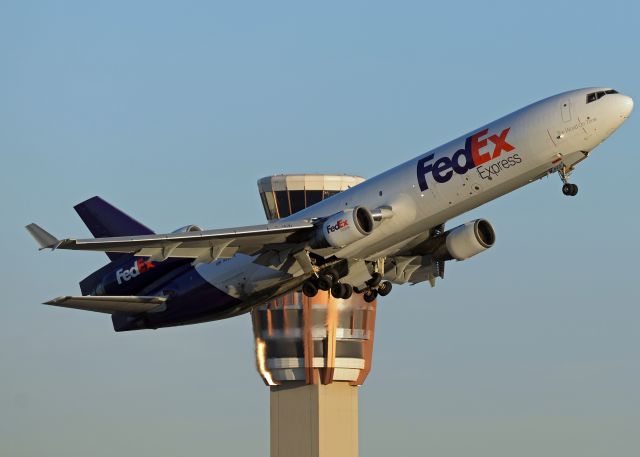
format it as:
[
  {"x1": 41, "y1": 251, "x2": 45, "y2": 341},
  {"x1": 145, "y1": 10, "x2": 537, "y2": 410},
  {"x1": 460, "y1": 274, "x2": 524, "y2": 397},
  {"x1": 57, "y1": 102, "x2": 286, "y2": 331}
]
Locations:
[{"x1": 26, "y1": 220, "x2": 316, "y2": 262}]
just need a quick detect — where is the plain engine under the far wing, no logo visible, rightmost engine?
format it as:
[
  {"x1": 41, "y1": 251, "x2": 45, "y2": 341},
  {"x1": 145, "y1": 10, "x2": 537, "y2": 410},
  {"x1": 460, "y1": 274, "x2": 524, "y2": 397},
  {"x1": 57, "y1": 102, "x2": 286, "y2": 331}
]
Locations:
[{"x1": 444, "y1": 219, "x2": 496, "y2": 260}]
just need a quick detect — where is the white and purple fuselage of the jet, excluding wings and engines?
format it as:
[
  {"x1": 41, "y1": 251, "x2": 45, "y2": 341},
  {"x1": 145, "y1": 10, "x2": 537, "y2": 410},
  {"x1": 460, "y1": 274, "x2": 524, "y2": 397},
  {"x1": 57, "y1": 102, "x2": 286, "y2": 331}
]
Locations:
[{"x1": 92, "y1": 89, "x2": 632, "y2": 330}]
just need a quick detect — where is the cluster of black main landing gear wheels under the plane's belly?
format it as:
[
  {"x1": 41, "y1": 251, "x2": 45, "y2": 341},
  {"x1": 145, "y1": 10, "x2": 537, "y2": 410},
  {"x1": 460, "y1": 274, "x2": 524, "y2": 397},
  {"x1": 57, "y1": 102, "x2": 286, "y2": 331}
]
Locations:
[{"x1": 302, "y1": 268, "x2": 392, "y2": 303}]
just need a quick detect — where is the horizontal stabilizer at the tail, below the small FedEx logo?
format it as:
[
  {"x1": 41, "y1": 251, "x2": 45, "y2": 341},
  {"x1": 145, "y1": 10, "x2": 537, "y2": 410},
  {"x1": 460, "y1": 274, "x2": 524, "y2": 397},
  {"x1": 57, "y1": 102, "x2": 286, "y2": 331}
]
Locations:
[{"x1": 44, "y1": 295, "x2": 167, "y2": 314}]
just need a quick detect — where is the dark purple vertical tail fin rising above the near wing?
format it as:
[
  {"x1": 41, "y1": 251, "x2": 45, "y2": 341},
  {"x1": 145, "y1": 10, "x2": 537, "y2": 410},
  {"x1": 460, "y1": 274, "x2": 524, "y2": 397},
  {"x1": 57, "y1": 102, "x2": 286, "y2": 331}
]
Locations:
[{"x1": 74, "y1": 197, "x2": 154, "y2": 260}]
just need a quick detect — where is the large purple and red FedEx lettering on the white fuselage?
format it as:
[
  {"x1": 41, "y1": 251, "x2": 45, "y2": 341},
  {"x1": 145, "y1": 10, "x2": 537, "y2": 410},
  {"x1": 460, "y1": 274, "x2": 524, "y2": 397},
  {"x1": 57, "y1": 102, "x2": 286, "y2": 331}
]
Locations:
[{"x1": 417, "y1": 127, "x2": 515, "y2": 191}]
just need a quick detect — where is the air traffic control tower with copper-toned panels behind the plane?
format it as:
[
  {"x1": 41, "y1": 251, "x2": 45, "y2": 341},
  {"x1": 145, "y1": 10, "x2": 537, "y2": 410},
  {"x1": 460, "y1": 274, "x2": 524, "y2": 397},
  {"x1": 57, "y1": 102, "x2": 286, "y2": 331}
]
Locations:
[{"x1": 251, "y1": 175, "x2": 376, "y2": 457}]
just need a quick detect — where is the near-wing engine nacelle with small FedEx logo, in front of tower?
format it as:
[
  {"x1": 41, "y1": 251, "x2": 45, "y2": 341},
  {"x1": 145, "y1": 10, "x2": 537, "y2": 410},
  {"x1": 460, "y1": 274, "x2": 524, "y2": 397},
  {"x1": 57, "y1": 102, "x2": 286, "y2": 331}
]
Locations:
[{"x1": 312, "y1": 206, "x2": 373, "y2": 248}]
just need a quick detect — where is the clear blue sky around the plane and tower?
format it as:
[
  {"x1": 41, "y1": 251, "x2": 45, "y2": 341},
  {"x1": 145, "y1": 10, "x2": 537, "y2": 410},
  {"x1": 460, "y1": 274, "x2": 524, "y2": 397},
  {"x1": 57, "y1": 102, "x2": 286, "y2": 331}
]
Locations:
[{"x1": 0, "y1": 0, "x2": 640, "y2": 457}]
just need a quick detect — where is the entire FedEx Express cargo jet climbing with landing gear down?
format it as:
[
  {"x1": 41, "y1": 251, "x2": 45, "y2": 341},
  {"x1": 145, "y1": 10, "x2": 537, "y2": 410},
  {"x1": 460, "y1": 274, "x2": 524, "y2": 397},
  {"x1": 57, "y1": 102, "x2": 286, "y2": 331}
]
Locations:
[{"x1": 27, "y1": 87, "x2": 633, "y2": 331}]
